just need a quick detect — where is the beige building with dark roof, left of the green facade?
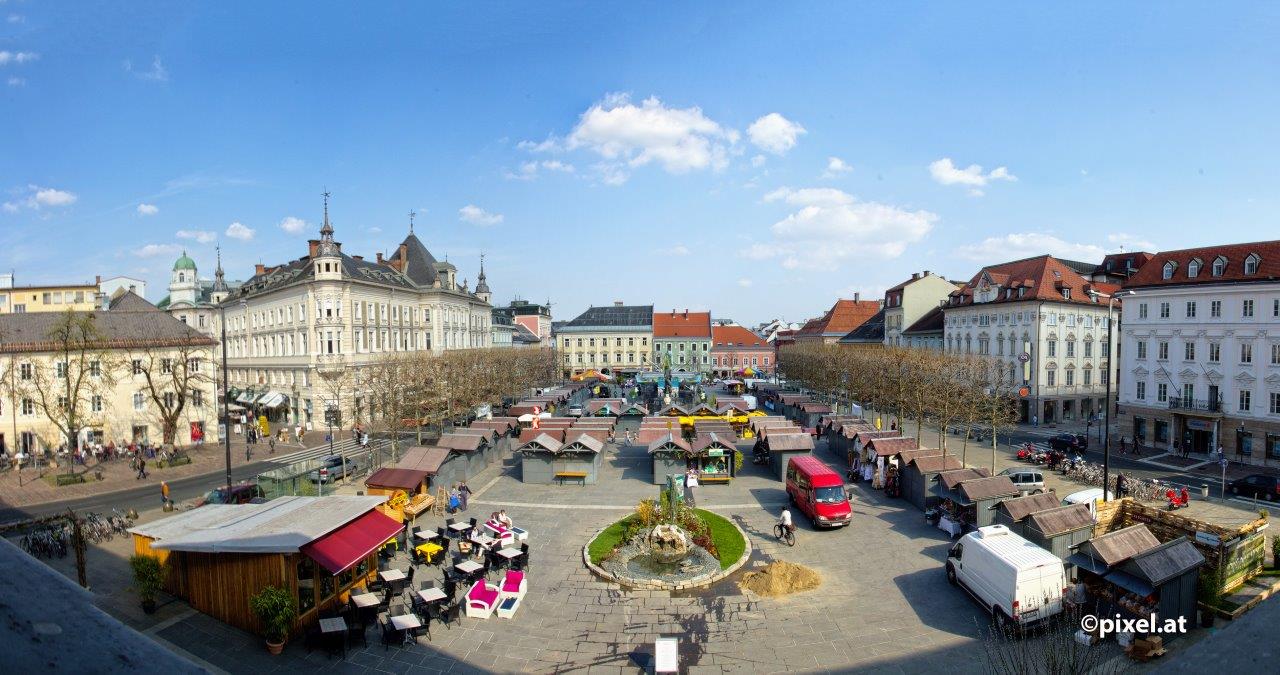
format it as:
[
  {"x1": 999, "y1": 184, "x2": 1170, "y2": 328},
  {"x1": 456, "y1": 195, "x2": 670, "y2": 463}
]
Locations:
[{"x1": 553, "y1": 302, "x2": 653, "y2": 377}]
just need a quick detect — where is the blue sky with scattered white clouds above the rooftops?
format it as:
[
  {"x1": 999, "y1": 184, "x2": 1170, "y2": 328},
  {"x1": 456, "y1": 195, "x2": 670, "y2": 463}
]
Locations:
[{"x1": 0, "y1": 0, "x2": 1280, "y2": 323}]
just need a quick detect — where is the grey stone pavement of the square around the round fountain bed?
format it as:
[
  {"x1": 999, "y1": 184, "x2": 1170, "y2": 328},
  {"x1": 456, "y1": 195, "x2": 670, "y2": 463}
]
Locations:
[{"x1": 30, "y1": 435, "x2": 1029, "y2": 674}]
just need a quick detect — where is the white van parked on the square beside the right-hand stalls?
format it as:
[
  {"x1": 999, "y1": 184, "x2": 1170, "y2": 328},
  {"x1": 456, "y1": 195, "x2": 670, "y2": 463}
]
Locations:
[{"x1": 947, "y1": 525, "x2": 1068, "y2": 629}]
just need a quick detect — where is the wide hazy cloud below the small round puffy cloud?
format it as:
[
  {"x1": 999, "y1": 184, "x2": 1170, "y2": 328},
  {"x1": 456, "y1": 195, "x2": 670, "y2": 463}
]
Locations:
[{"x1": 740, "y1": 187, "x2": 938, "y2": 269}]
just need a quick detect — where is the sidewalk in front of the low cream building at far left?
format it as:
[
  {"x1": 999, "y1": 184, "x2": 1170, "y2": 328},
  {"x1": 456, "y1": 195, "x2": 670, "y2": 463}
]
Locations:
[{"x1": 0, "y1": 434, "x2": 308, "y2": 507}]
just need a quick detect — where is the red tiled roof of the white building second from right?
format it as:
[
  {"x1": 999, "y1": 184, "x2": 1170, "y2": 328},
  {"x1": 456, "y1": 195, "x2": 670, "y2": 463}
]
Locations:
[{"x1": 947, "y1": 255, "x2": 1120, "y2": 307}]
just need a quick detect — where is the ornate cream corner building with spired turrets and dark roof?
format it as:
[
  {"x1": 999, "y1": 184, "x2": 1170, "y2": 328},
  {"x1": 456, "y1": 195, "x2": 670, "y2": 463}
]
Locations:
[{"x1": 215, "y1": 200, "x2": 493, "y2": 428}]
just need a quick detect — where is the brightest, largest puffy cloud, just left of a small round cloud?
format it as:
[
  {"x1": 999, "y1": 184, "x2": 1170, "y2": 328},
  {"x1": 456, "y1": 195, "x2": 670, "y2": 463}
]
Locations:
[{"x1": 552, "y1": 94, "x2": 739, "y2": 184}]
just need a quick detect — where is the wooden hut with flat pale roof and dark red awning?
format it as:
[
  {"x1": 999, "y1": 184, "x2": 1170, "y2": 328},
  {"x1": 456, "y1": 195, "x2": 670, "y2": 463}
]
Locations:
[{"x1": 129, "y1": 496, "x2": 402, "y2": 633}]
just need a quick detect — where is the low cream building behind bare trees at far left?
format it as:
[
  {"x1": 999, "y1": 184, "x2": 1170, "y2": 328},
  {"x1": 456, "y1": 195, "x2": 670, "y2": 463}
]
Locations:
[{"x1": 0, "y1": 292, "x2": 218, "y2": 455}]
